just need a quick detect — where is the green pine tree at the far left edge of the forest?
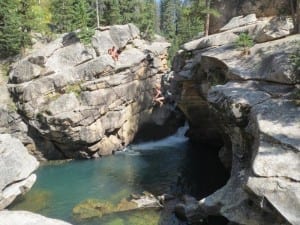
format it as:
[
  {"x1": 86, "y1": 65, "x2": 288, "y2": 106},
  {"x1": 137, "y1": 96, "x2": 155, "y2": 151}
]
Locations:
[{"x1": 0, "y1": 0, "x2": 22, "y2": 58}]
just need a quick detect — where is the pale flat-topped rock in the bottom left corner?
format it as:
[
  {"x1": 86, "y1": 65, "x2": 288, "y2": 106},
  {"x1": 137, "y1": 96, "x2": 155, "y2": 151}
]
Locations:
[{"x1": 0, "y1": 210, "x2": 71, "y2": 225}]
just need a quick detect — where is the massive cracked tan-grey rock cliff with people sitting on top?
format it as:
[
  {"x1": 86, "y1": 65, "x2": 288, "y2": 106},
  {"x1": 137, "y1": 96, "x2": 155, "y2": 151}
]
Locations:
[{"x1": 9, "y1": 24, "x2": 170, "y2": 159}]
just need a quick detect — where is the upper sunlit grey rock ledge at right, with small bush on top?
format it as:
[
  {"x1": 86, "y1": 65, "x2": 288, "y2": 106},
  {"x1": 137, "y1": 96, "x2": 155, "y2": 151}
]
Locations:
[{"x1": 202, "y1": 35, "x2": 300, "y2": 84}]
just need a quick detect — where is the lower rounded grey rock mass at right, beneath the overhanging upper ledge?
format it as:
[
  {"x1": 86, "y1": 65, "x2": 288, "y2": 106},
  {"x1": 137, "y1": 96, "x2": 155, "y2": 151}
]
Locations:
[{"x1": 204, "y1": 81, "x2": 300, "y2": 224}]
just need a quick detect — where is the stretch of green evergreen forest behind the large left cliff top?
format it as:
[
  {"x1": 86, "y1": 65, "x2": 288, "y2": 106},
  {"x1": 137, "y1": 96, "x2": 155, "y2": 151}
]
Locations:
[{"x1": 0, "y1": 0, "x2": 214, "y2": 57}]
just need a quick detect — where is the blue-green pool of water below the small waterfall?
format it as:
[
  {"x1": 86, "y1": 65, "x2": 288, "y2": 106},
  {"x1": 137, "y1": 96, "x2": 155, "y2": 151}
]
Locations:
[{"x1": 12, "y1": 128, "x2": 227, "y2": 225}]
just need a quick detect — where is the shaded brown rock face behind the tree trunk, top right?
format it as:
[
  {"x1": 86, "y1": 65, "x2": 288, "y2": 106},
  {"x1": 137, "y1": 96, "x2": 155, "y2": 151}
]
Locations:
[{"x1": 210, "y1": 0, "x2": 290, "y2": 33}]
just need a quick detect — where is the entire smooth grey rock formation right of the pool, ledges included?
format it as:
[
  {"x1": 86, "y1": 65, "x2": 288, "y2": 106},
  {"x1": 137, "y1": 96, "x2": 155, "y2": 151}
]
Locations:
[{"x1": 169, "y1": 14, "x2": 300, "y2": 225}]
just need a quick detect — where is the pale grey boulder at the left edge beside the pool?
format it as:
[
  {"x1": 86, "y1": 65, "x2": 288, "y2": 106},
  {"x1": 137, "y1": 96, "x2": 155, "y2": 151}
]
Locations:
[{"x1": 0, "y1": 134, "x2": 39, "y2": 209}]
